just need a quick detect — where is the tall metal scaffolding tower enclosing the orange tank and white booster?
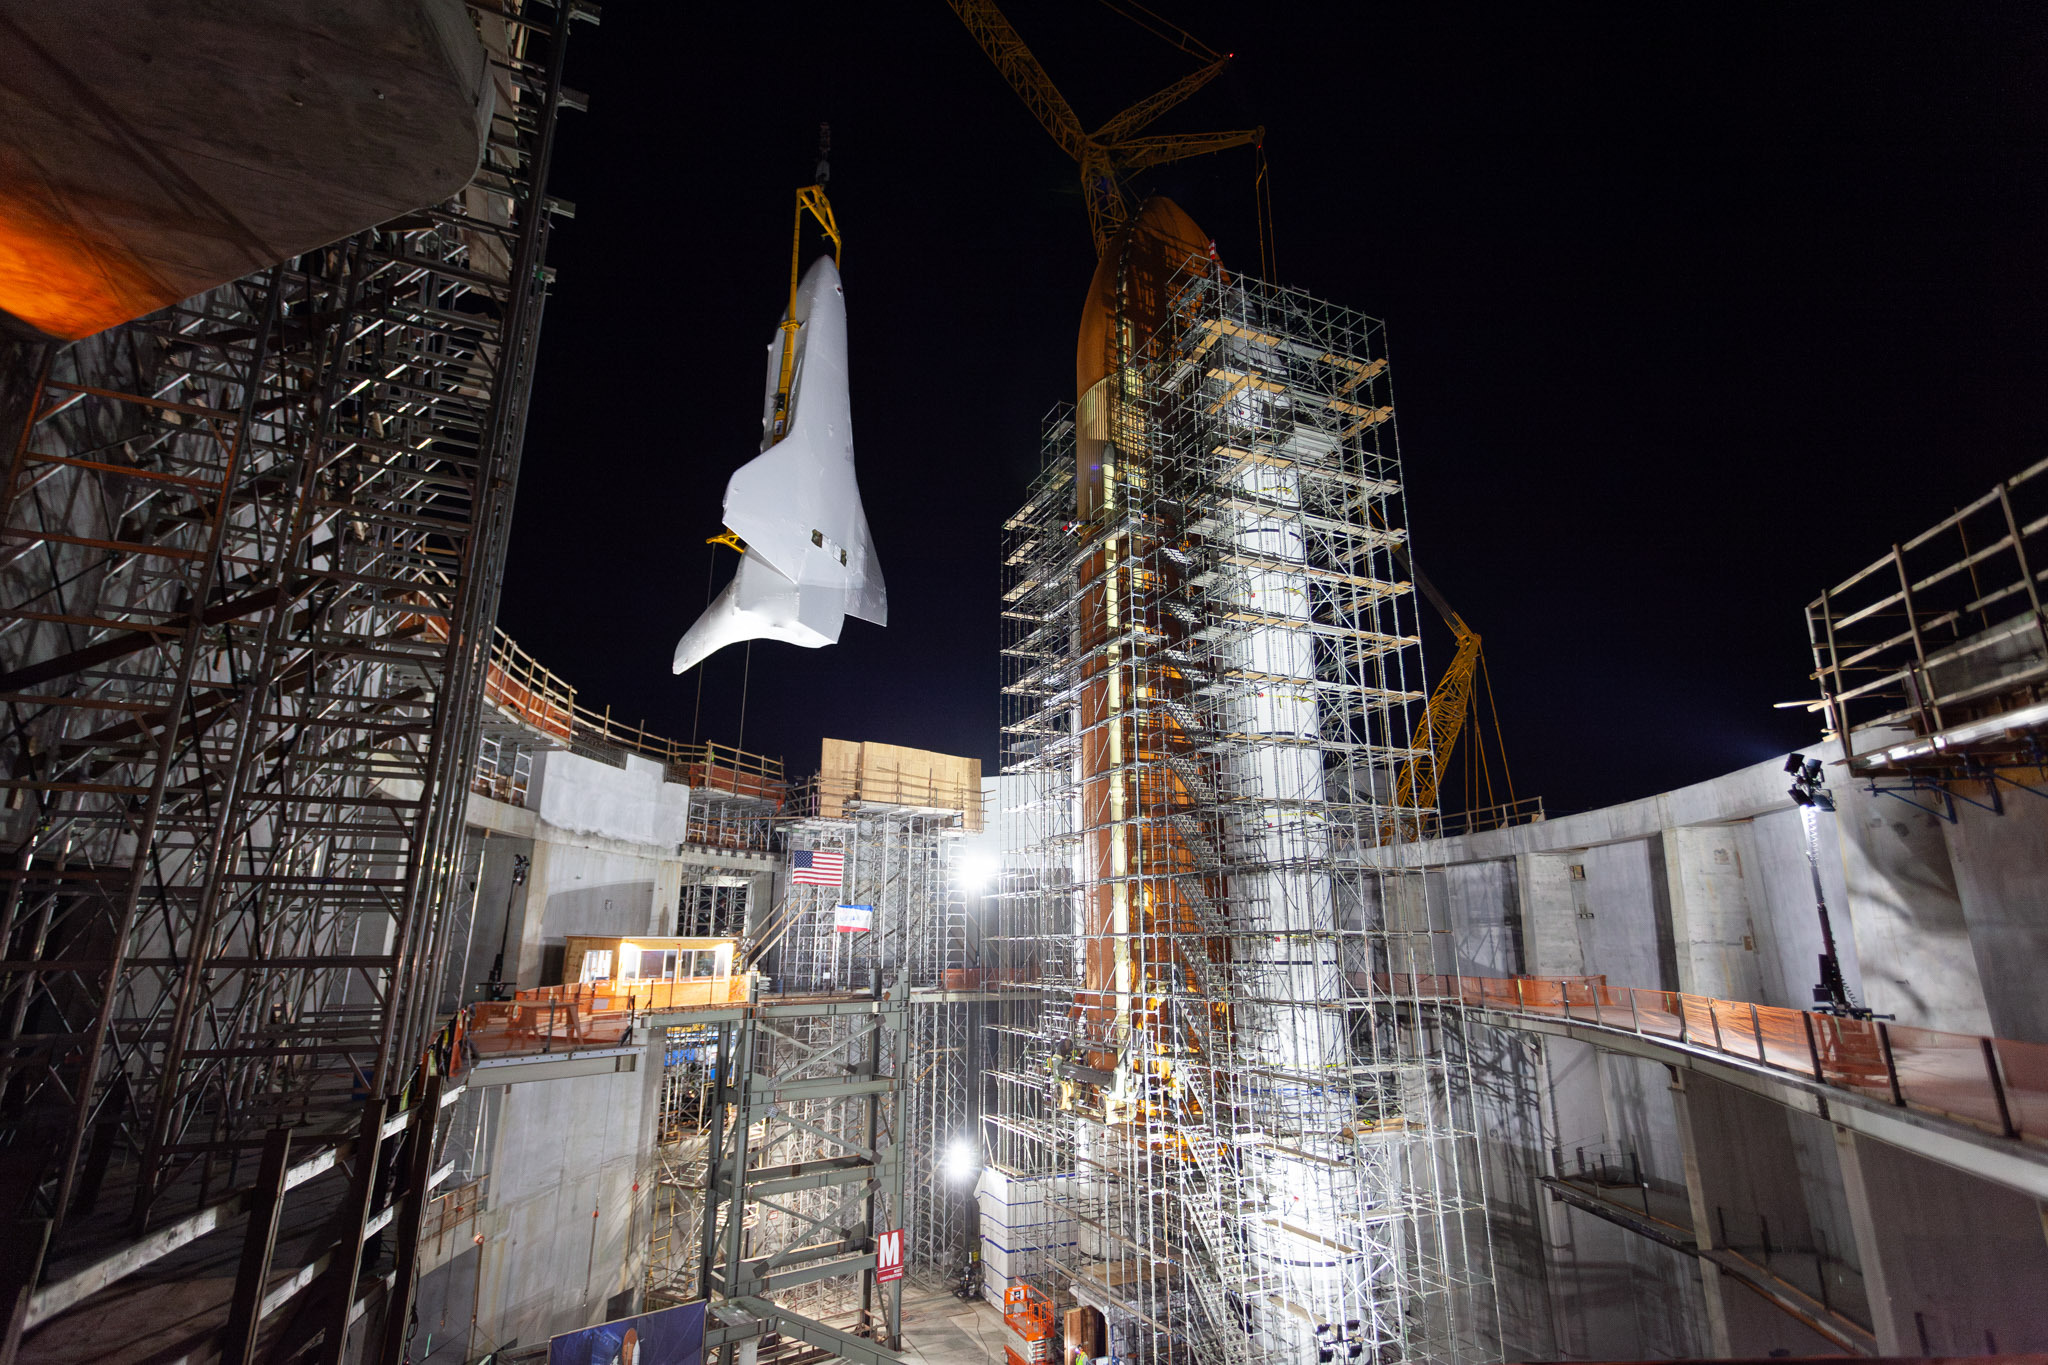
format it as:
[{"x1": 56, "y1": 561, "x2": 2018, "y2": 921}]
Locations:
[{"x1": 985, "y1": 260, "x2": 1497, "y2": 1363}]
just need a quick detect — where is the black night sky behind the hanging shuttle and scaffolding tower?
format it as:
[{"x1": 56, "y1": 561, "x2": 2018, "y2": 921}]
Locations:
[{"x1": 500, "y1": 0, "x2": 2048, "y2": 812}]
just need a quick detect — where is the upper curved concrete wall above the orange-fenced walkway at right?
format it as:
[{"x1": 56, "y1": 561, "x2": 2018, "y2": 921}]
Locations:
[{"x1": 1407, "y1": 737, "x2": 2048, "y2": 1042}]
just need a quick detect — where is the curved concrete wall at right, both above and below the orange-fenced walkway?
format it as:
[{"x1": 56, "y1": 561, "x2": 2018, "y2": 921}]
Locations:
[{"x1": 1433, "y1": 743, "x2": 2048, "y2": 1359}]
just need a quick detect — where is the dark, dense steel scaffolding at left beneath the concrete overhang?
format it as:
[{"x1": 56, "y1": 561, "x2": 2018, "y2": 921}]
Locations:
[{"x1": 0, "y1": 0, "x2": 588, "y2": 1326}]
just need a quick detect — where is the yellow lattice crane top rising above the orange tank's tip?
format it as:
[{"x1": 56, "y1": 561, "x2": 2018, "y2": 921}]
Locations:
[{"x1": 946, "y1": 0, "x2": 1266, "y2": 256}]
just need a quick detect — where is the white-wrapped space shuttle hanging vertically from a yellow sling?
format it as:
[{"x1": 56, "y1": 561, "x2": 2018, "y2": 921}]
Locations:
[{"x1": 674, "y1": 256, "x2": 889, "y2": 673}]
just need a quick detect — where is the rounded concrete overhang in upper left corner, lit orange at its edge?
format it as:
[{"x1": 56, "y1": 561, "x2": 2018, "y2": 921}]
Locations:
[{"x1": 0, "y1": 0, "x2": 502, "y2": 340}]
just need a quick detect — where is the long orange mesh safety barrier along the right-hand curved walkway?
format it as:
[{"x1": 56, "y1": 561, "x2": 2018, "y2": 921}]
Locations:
[{"x1": 1374, "y1": 974, "x2": 2048, "y2": 1144}]
